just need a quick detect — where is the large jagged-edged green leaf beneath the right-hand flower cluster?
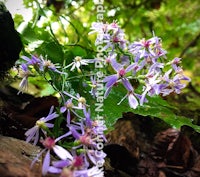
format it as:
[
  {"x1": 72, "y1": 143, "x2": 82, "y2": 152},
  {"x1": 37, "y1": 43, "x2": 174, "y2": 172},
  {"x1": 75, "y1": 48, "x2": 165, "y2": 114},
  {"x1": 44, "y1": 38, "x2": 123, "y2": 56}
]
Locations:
[{"x1": 98, "y1": 85, "x2": 200, "y2": 132}]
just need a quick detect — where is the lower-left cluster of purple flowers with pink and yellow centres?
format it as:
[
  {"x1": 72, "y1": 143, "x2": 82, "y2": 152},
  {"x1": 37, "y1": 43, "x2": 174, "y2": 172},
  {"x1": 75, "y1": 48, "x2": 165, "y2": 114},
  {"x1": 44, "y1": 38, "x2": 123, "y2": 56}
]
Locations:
[{"x1": 25, "y1": 96, "x2": 106, "y2": 177}]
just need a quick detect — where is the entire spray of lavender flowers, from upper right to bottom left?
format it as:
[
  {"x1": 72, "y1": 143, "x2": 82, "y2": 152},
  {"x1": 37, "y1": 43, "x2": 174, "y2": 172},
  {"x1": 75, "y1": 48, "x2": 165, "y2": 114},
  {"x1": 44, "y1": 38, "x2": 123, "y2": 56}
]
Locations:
[{"x1": 19, "y1": 22, "x2": 190, "y2": 177}]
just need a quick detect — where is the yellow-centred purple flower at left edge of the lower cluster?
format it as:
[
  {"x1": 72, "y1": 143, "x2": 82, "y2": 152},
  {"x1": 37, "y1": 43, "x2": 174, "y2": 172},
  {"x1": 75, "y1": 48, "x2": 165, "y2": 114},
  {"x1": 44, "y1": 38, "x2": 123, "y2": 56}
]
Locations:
[{"x1": 25, "y1": 106, "x2": 58, "y2": 145}]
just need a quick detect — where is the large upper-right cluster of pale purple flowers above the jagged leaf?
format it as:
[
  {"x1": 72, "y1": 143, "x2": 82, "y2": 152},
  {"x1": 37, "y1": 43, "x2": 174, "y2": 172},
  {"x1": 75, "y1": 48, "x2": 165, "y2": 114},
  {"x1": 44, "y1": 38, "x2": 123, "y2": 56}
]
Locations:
[{"x1": 91, "y1": 22, "x2": 190, "y2": 109}]
